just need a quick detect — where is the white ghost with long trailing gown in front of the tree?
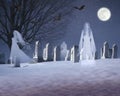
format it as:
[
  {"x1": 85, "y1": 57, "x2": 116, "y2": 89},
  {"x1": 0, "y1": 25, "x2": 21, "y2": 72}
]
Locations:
[{"x1": 10, "y1": 30, "x2": 31, "y2": 62}]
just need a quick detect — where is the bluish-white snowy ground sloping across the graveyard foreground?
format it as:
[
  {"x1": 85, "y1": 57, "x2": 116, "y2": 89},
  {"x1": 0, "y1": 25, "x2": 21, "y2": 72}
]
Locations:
[{"x1": 0, "y1": 59, "x2": 120, "y2": 96}]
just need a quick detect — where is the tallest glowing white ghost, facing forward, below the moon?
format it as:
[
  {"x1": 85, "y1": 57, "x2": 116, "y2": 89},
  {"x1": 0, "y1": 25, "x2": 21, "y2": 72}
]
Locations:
[{"x1": 79, "y1": 23, "x2": 96, "y2": 60}]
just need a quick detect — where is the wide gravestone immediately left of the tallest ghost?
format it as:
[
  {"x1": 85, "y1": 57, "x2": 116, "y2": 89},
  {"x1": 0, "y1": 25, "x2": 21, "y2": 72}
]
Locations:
[{"x1": 70, "y1": 46, "x2": 79, "y2": 62}]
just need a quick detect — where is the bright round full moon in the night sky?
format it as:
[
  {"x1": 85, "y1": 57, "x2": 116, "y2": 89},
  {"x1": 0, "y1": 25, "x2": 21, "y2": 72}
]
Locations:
[{"x1": 97, "y1": 7, "x2": 111, "y2": 21}]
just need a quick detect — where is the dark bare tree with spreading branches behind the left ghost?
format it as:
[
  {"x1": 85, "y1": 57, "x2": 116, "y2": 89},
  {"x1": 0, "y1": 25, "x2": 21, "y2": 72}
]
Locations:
[{"x1": 0, "y1": 0, "x2": 73, "y2": 48}]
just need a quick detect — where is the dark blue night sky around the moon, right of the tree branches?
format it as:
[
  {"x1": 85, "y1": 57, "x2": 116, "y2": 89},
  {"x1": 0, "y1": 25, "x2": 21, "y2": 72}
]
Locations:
[{"x1": 62, "y1": 0, "x2": 120, "y2": 57}]
